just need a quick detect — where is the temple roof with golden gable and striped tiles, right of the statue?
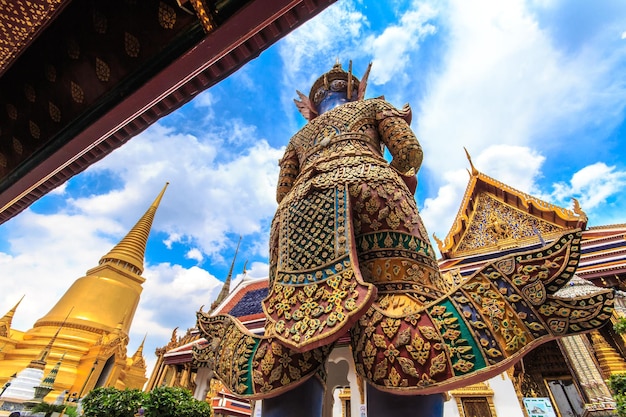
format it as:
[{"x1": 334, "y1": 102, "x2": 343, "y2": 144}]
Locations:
[{"x1": 435, "y1": 159, "x2": 626, "y2": 290}]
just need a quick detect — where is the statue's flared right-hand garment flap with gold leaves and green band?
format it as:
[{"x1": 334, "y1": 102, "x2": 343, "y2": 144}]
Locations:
[{"x1": 351, "y1": 231, "x2": 613, "y2": 394}]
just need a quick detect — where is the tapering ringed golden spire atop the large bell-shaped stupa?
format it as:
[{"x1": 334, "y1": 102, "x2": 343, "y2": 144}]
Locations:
[{"x1": 95, "y1": 182, "x2": 169, "y2": 275}]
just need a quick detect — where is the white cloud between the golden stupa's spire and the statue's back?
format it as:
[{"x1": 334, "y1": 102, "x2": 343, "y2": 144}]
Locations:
[{"x1": 83, "y1": 123, "x2": 282, "y2": 257}]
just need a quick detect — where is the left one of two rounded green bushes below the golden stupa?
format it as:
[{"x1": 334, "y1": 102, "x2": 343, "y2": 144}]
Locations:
[{"x1": 83, "y1": 388, "x2": 147, "y2": 417}]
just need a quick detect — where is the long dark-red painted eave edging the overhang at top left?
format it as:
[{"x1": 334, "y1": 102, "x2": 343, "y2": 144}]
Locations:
[{"x1": 0, "y1": 0, "x2": 335, "y2": 223}]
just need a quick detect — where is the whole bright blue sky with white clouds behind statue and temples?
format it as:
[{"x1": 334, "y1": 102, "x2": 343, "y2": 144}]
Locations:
[{"x1": 0, "y1": 0, "x2": 626, "y2": 376}]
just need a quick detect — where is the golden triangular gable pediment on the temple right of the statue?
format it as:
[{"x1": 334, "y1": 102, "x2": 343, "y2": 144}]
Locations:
[{"x1": 438, "y1": 170, "x2": 587, "y2": 259}]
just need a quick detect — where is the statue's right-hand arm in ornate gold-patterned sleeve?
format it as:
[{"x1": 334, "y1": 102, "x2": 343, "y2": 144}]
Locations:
[{"x1": 376, "y1": 102, "x2": 423, "y2": 176}]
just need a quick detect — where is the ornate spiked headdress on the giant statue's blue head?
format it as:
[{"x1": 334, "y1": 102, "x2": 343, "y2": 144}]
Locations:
[{"x1": 293, "y1": 61, "x2": 372, "y2": 120}]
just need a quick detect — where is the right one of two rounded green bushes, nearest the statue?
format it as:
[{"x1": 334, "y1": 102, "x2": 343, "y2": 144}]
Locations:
[{"x1": 143, "y1": 387, "x2": 211, "y2": 417}]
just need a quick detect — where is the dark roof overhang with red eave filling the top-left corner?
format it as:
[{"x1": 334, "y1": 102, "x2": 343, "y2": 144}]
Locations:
[{"x1": 0, "y1": 0, "x2": 334, "y2": 223}]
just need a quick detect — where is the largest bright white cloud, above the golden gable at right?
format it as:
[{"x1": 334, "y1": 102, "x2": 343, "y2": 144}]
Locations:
[{"x1": 415, "y1": 0, "x2": 624, "y2": 180}]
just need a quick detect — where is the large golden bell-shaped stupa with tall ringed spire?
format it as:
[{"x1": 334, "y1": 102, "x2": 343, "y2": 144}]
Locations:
[{"x1": 0, "y1": 184, "x2": 167, "y2": 399}]
